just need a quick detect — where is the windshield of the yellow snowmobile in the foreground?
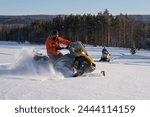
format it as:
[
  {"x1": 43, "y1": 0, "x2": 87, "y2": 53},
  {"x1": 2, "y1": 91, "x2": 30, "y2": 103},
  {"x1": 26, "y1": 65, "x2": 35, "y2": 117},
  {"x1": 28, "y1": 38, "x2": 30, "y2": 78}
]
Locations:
[{"x1": 70, "y1": 41, "x2": 87, "y2": 54}]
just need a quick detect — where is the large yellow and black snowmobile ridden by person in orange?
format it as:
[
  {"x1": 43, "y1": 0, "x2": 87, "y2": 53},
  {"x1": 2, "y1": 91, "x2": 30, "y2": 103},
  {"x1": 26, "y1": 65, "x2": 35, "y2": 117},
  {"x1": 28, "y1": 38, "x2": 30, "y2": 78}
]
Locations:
[{"x1": 34, "y1": 41, "x2": 96, "y2": 77}]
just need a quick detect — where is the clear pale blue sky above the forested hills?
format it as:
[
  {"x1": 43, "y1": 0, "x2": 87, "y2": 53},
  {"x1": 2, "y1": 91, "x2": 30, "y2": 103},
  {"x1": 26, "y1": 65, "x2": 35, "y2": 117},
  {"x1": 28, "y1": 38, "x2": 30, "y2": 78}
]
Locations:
[{"x1": 0, "y1": 0, "x2": 150, "y2": 15}]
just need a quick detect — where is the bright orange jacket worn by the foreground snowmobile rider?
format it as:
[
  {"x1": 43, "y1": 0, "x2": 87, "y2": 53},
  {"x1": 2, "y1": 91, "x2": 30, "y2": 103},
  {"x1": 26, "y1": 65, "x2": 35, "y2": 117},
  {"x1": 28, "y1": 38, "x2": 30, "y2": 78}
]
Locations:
[{"x1": 46, "y1": 36, "x2": 71, "y2": 55}]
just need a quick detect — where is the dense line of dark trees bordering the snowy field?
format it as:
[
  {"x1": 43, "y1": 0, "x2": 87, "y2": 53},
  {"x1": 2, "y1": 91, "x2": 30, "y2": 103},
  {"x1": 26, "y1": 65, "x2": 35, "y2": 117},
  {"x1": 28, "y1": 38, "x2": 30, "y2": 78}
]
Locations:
[{"x1": 0, "y1": 9, "x2": 150, "y2": 48}]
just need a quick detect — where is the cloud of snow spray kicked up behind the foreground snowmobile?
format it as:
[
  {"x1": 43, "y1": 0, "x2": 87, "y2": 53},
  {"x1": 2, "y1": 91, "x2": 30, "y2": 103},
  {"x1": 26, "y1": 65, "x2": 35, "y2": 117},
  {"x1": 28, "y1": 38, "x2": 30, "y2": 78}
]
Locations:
[{"x1": 0, "y1": 47, "x2": 64, "y2": 80}]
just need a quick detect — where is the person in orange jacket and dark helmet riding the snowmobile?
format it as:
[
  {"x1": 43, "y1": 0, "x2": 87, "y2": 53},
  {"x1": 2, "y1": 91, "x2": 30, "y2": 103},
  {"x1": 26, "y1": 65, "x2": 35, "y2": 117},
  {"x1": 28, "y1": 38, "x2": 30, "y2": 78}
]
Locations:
[{"x1": 46, "y1": 30, "x2": 71, "y2": 61}]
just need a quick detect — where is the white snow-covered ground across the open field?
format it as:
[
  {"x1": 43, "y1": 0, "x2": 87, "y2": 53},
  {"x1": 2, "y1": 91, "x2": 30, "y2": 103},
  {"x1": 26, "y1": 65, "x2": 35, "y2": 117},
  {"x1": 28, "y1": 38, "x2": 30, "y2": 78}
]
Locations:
[{"x1": 0, "y1": 42, "x2": 150, "y2": 100}]
